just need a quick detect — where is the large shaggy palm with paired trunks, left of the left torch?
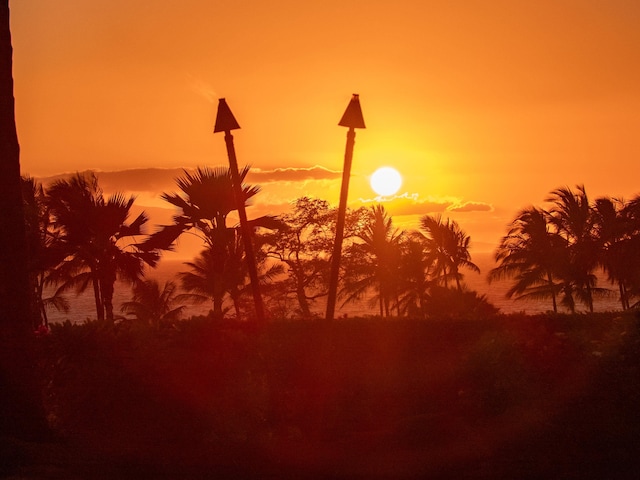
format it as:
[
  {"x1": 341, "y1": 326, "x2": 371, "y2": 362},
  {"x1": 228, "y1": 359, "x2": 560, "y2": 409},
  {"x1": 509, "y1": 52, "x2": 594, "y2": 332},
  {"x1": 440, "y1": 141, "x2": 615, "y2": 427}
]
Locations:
[{"x1": 48, "y1": 174, "x2": 159, "y2": 321}]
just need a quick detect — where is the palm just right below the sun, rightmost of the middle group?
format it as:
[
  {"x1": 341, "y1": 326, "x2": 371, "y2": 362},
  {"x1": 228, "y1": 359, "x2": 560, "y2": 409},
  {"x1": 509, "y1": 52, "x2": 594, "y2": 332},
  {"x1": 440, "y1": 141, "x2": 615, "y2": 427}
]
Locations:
[{"x1": 420, "y1": 215, "x2": 480, "y2": 291}]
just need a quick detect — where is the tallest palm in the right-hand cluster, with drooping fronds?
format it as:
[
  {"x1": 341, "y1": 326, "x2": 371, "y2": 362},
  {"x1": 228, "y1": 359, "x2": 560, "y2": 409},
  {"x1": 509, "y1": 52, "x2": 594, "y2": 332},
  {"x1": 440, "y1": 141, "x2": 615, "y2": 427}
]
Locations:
[{"x1": 546, "y1": 185, "x2": 606, "y2": 312}]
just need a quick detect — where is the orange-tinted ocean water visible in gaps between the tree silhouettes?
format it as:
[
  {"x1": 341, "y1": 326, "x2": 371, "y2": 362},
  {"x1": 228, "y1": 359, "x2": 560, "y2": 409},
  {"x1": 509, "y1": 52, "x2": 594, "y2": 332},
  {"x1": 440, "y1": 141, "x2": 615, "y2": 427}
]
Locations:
[{"x1": 48, "y1": 249, "x2": 620, "y2": 323}]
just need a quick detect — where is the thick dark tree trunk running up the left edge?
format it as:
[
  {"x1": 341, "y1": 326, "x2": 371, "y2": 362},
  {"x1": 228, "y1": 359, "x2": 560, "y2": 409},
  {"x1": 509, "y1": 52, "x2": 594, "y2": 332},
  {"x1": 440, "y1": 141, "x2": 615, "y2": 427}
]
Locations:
[{"x1": 0, "y1": 0, "x2": 46, "y2": 439}]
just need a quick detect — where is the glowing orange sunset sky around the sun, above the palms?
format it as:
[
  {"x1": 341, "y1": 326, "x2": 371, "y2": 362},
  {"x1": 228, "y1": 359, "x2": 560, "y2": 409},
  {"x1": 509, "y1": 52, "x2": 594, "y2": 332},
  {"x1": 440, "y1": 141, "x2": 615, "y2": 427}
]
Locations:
[{"x1": 11, "y1": 0, "x2": 640, "y2": 251}]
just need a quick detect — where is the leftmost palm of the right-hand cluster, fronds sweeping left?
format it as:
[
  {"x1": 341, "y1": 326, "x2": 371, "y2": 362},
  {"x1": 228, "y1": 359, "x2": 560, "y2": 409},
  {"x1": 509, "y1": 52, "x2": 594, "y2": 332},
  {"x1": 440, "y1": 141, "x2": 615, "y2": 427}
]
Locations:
[{"x1": 488, "y1": 207, "x2": 566, "y2": 313}]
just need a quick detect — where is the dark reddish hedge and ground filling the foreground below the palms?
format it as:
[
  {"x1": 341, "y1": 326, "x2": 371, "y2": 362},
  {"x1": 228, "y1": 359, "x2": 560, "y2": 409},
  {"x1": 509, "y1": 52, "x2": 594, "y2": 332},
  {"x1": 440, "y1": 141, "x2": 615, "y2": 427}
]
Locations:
[{"x1": 0, "y1": 314, "x2": 640, "y2": 479}]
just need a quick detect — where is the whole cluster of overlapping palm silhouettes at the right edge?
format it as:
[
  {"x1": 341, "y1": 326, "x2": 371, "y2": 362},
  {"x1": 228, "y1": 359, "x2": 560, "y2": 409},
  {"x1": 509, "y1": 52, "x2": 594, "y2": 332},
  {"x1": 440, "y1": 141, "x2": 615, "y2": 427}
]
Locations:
[{"x1": 488, "y1": 186, "x2": 640, "y2": 313}]
